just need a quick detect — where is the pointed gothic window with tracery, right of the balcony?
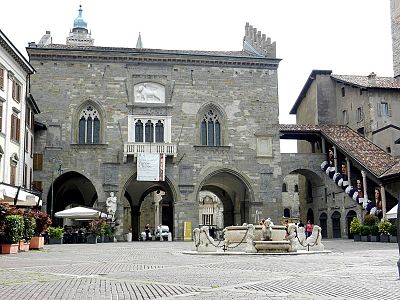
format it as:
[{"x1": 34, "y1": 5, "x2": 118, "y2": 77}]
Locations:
[{"x1": 201, "y1": 109, "x2": 221, "y2": 146}]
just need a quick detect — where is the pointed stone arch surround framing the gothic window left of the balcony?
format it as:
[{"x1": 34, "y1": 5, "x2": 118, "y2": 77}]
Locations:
[{"x1": 71, "y1": 99, "x2": 107, "y2": 144}]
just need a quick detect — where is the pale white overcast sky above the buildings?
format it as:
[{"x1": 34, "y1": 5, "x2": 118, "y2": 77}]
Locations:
[{"x1": 0, "y1": 0, "x2": 393, "y2": 152}]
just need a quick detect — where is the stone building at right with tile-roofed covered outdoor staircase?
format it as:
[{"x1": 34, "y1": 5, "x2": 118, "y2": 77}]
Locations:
[{"x1": 281, "y1": 0, "x2": 400, "y2": 237}]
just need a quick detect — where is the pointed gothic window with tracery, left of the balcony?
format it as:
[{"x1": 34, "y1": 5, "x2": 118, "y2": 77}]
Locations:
[{"x1": 78, "y1": 105, "x2": 100, "y2": 144}]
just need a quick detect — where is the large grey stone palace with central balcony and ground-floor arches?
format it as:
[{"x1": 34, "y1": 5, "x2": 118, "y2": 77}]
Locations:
[{"x1": 27, "y1": 8, "x2": 282, "y2": 239}]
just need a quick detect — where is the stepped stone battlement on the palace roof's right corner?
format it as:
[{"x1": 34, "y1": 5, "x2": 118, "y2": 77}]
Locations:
[{"x1": 243, "y1": 23, "x2": 276, "y2": 58}]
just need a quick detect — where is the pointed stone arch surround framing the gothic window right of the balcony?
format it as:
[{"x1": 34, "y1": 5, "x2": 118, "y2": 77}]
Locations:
[{"x1": 196, "y1": 102, "x2": 227, "y2": 146}]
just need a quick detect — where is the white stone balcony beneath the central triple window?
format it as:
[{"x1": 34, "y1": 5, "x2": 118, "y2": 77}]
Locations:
[{"x1": 124, "y1": 143, "x2": 177, "y2": 160}]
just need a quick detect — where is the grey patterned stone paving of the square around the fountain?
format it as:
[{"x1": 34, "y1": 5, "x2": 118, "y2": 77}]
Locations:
[{"x1": 0, "y1": 240, "x2": 400, "y2": 300}]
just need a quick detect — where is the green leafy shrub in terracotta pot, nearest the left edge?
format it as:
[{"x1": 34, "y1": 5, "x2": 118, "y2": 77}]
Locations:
[{"x1": 1, "y1": 215, "x2": 24, "y2": 254}]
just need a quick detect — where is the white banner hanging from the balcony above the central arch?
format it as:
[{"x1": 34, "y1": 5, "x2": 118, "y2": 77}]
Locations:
[{"x1": 137, "y1": 153, "x2": 165, "y2": 181}]
